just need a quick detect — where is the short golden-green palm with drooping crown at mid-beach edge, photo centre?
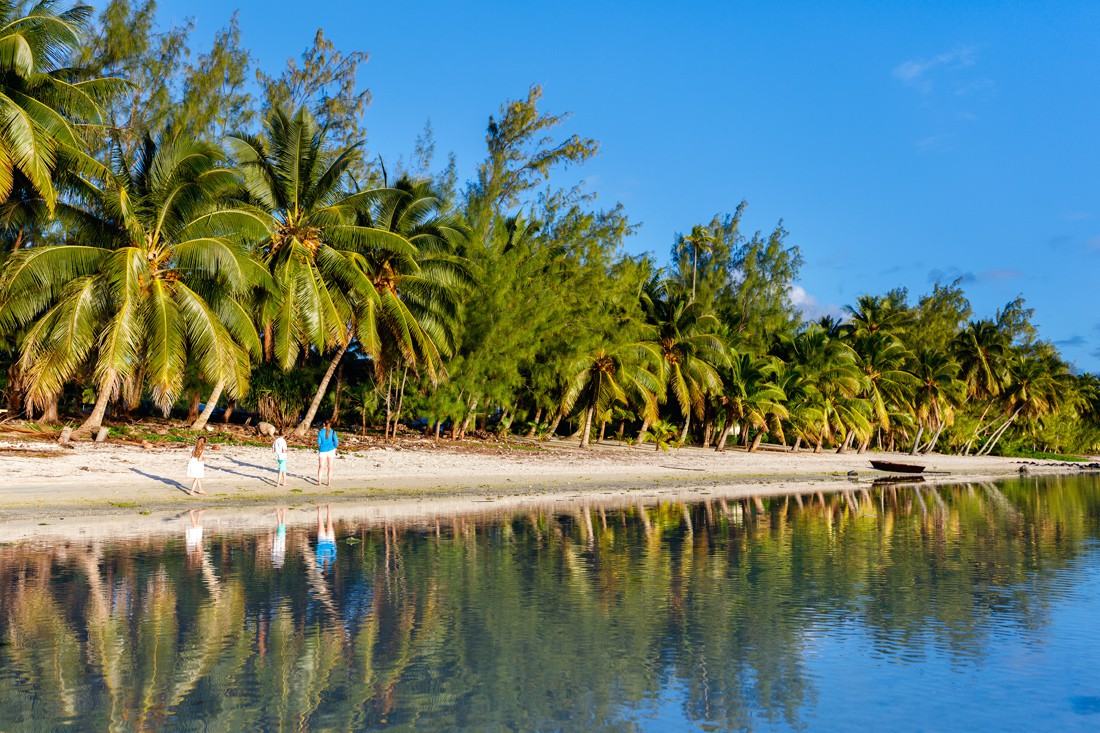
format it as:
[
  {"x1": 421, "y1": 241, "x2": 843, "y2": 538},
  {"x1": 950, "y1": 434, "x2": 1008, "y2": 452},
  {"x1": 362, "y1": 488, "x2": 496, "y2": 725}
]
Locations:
[{"x1": 561, "y1": 344, "x2": 661, "y2": 448}]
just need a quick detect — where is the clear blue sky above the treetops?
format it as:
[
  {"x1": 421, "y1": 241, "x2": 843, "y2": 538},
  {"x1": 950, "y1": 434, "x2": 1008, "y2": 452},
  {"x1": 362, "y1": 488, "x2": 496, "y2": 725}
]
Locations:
[{"x1": 161, "y1": 0, "x2": 1100, "y2": 371}]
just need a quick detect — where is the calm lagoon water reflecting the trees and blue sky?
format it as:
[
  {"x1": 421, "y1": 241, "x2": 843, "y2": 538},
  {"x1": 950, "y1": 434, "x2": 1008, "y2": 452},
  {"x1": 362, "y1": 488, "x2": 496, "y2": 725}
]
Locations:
[{"x1": 0, "y1": 477, "x2": 1100, "y2": 731}]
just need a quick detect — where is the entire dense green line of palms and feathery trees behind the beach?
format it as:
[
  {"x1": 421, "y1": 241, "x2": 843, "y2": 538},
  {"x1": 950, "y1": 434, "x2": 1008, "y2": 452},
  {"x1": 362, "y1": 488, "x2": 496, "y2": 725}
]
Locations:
[{"x1": 0, "y1": 0, "x2": 1100, "y2": 453}]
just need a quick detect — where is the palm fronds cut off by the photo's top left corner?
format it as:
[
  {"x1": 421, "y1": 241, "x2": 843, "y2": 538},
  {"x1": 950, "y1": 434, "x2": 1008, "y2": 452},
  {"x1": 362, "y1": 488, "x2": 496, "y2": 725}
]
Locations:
[{"x1": 0, "y1": 0, "x2": 125, "y2": 211}]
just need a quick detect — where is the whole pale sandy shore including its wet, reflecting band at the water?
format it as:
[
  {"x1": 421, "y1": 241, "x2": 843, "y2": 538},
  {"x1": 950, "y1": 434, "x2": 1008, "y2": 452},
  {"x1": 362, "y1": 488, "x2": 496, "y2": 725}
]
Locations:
[{"x1": 0, "y1": 439, "x2": 1079, "y2": 541}]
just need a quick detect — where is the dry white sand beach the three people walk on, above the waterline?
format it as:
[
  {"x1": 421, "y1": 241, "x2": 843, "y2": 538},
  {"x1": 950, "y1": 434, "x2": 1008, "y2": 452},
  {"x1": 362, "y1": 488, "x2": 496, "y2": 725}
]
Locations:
[{"x1": 0, "y1": 438, "x2": 1079, "y2": 519}]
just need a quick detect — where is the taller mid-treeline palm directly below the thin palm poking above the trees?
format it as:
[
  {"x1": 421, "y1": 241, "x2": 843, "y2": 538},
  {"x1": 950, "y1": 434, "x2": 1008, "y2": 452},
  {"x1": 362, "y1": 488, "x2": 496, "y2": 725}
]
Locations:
[{"x1": 641, "y1": 278, "x2": 729, "y2": 439}]
